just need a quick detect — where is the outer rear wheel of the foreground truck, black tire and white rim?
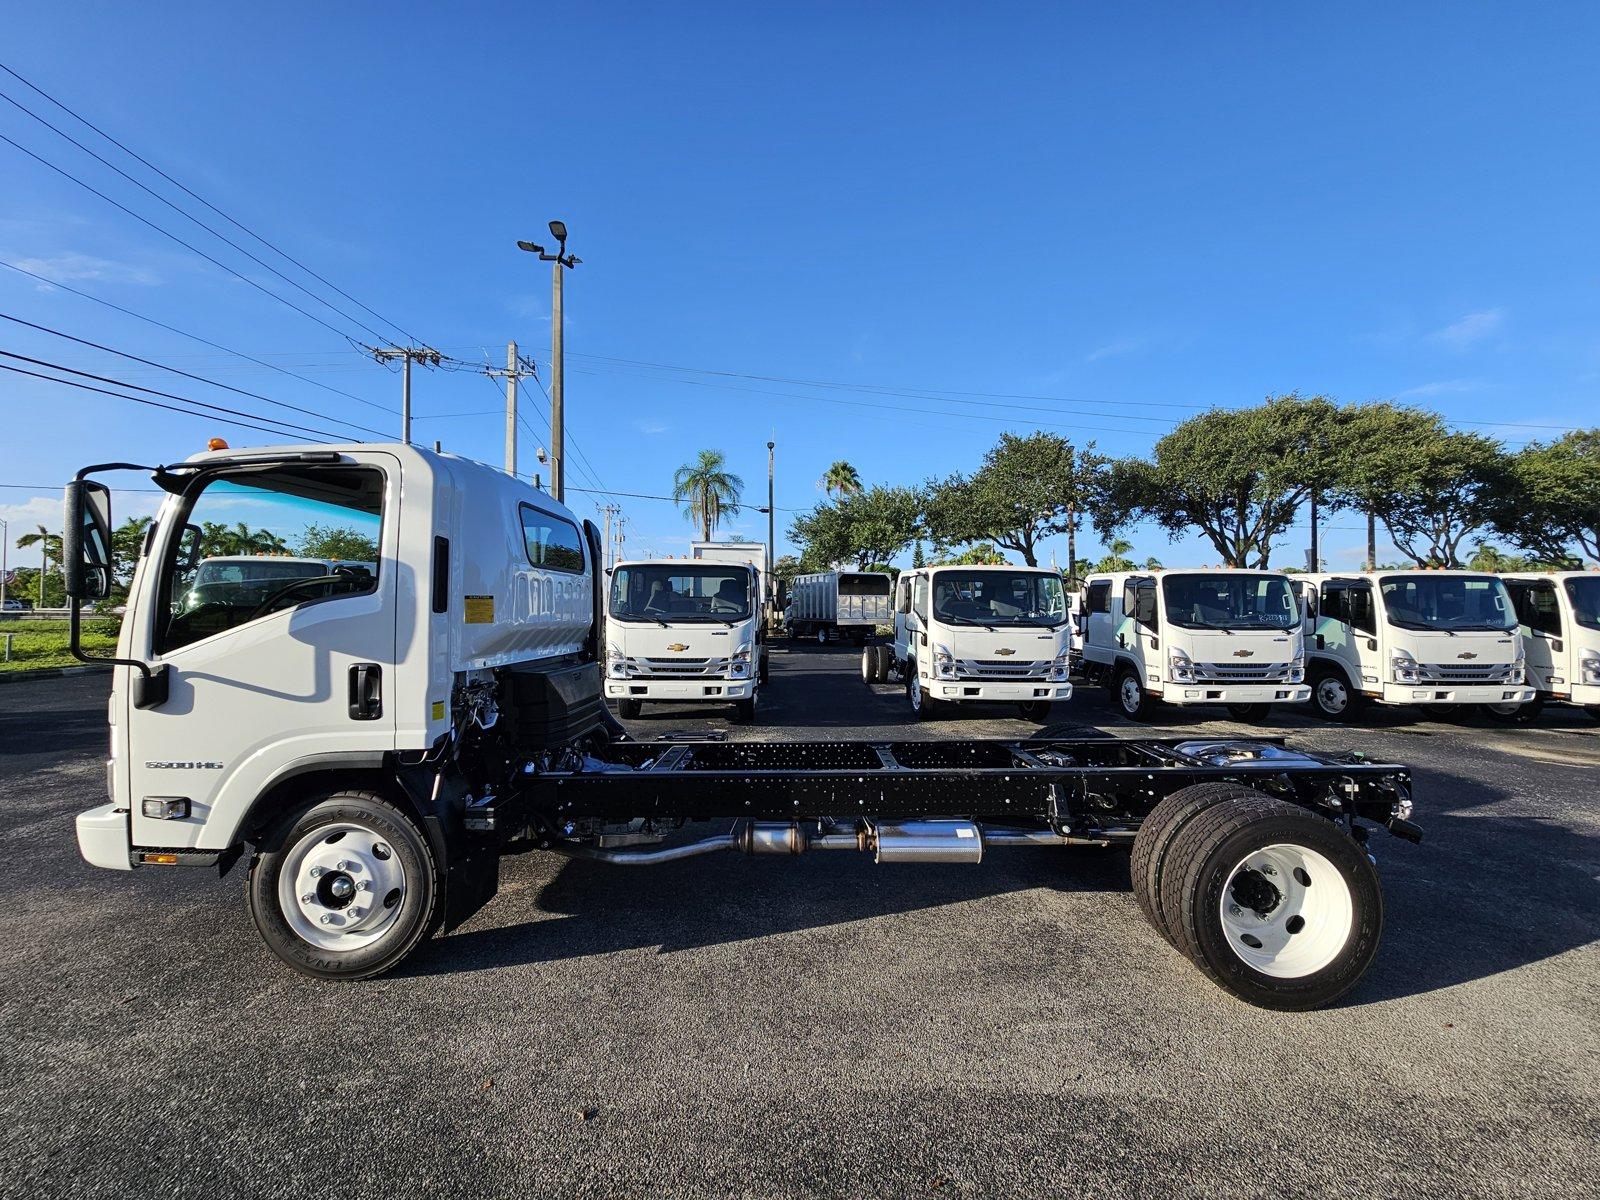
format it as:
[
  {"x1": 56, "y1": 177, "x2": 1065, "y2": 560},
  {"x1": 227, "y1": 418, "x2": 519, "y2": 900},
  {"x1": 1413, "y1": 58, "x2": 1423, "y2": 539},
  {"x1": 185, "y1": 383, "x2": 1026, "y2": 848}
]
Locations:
[{"x1": 1162, "y1": 794, "x2": 1384, "y2": 1011}]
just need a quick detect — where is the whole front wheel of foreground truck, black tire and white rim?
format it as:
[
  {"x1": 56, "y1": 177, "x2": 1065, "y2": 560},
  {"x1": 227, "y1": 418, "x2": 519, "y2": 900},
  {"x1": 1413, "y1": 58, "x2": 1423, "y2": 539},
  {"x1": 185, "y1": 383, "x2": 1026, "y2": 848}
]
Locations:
[{"x1": 245, "y1": 792, "x2": 442, "y2": 979}]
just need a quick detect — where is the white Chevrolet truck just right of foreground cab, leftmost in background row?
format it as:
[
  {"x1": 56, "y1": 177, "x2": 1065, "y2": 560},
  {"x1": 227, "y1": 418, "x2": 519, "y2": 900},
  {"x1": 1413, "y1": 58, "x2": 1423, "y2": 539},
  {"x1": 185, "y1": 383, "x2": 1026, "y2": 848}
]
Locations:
[{"x1": 605, "y1": 558, "x2": 766, "y2": 722}]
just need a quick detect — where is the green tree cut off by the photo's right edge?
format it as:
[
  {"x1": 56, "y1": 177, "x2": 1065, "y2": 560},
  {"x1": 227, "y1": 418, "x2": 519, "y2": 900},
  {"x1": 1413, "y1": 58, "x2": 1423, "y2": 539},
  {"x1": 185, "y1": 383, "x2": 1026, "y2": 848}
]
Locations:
[{"x1": 1490, "y1": 429, "x2": 1600, "y2": 563}]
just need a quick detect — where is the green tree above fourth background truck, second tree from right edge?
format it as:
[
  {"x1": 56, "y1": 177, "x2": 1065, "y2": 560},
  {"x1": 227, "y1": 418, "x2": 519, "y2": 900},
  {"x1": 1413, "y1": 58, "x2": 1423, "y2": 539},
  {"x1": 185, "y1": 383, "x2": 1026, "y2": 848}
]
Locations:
[{"x1": 1338, "y1": 403, "x2": 1507, "y2": 566}]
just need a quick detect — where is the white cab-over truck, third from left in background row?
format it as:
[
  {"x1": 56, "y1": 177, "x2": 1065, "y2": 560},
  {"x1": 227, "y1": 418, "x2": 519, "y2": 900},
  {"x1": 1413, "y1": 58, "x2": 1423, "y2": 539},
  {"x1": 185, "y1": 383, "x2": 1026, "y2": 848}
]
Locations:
[{"x1": 1082, "y1": 568, "x2": 1310, "y2": 720}]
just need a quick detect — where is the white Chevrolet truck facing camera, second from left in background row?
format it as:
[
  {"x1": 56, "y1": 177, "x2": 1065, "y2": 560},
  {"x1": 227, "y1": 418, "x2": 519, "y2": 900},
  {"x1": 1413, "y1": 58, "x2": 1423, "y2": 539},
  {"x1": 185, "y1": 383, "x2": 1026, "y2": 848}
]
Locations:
[{"x1": 893, "y1": 566, "x2": 1072, "y2": 723}]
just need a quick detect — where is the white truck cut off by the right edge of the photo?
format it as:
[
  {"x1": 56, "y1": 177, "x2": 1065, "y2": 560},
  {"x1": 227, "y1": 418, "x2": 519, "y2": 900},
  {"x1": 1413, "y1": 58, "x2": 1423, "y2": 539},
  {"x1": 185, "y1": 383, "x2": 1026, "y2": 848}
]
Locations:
[{"x1": 1485, "y1": 571, "x2": 1600, "y2": 722}]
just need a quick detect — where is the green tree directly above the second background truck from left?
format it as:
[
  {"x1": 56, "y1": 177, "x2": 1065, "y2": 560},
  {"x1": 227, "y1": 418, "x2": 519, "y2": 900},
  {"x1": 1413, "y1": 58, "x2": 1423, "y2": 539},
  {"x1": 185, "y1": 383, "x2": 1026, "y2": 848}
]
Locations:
[{"x1": 926, "y1": 432, "x2": 1109, "y2": 574}]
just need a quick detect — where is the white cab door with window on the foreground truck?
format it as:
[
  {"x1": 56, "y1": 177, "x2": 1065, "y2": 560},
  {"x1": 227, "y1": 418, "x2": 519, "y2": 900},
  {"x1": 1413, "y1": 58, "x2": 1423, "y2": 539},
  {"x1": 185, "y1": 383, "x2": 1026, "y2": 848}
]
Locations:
[{"x1": 126, "y1": 453, "x2": 400, "y2": 848}]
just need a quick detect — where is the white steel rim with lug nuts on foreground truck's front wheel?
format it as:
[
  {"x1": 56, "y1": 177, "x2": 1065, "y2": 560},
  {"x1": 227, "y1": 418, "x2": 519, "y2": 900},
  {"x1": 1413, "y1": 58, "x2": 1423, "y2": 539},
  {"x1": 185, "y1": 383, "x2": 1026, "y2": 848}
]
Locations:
[{"x1": 278, "y1": 821, "x2": 406, "y2": 954}]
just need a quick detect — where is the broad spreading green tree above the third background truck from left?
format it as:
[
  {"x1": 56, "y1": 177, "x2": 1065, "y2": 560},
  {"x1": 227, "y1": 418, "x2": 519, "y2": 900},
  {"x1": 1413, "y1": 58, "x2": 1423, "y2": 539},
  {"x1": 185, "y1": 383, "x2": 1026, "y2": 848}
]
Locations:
[{"x1": 1120, "y1": 392, "x2": 1352, "y2": 568}]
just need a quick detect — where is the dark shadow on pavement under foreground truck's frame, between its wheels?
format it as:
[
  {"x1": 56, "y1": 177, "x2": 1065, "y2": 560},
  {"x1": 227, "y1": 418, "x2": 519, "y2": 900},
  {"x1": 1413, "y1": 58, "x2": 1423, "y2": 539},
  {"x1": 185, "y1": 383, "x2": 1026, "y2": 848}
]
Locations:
[{"x1": 402, "y1": 826, "x2": 1131, "y2": 974}]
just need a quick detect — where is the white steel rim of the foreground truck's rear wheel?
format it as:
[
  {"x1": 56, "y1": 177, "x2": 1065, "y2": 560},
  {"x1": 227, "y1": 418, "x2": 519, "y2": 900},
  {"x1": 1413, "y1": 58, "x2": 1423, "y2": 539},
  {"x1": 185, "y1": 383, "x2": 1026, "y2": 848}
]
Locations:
[{"x1": 1221, "y1": 842, "x2": 1355, "y2": 979}]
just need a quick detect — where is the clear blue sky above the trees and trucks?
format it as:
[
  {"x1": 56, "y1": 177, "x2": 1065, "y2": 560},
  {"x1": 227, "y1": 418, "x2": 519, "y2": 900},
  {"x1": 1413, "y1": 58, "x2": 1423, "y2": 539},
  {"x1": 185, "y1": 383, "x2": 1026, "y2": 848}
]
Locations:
[{"x1": 0, "y1": 0, "x2": 1600, "y2": 566}]
